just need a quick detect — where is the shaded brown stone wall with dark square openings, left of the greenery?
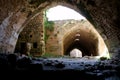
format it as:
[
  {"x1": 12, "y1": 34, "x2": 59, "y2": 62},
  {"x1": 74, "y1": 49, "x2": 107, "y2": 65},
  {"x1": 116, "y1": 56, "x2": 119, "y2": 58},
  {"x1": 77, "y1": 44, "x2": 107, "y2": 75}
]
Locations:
[{"x1": 15, "y1": 15, "x2": 43, "y2": 56}]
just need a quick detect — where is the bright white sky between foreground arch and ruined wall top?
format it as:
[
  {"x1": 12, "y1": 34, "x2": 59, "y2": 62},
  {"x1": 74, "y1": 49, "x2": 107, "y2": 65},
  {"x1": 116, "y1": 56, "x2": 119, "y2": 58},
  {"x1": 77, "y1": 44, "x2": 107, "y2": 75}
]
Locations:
[{"x1": 46, "y1": 5, "x2": 86, "y2": 21}]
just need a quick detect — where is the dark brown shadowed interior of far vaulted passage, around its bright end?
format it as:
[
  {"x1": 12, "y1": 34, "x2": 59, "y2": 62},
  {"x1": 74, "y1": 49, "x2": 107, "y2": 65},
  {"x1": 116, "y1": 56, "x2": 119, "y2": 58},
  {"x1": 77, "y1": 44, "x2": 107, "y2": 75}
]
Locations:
[{"x1": 64, "y1": 31, "x2": 98, "y2": 56}]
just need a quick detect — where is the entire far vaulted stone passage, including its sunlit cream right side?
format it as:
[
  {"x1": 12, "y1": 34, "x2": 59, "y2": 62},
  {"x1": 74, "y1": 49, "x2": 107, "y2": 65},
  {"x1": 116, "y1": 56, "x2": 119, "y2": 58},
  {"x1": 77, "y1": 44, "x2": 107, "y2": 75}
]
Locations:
[{"x1": 63, "y1": 22, "x2": 109, "y2": 57}]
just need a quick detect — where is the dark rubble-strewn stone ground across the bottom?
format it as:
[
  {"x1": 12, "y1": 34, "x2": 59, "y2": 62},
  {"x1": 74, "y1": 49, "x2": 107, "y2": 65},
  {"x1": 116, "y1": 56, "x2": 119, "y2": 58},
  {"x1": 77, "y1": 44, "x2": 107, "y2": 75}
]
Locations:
[{"x1": 0, "y1": 54, "x2": 120, "y2": 80}]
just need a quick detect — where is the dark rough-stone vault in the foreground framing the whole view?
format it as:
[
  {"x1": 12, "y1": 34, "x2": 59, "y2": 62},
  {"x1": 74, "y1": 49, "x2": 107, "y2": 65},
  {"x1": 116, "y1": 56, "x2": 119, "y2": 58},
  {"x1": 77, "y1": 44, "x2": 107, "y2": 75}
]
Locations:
[{"x1": 0, "y1": 0, "x2": 120, "y2": 57}]
